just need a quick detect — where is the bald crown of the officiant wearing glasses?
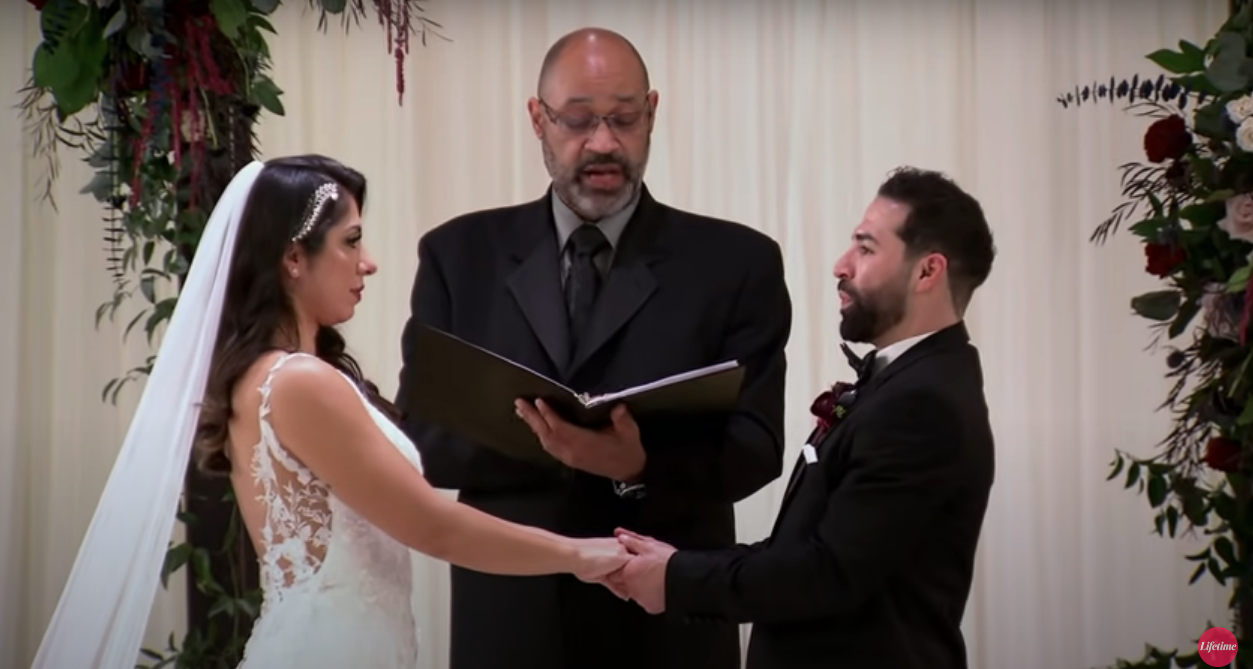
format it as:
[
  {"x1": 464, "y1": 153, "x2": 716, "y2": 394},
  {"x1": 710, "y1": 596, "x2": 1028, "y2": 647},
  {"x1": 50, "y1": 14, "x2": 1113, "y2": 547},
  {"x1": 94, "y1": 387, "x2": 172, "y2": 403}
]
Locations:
[{"x1": 535, "y1": 28, "x2": 649, "y2": 98}]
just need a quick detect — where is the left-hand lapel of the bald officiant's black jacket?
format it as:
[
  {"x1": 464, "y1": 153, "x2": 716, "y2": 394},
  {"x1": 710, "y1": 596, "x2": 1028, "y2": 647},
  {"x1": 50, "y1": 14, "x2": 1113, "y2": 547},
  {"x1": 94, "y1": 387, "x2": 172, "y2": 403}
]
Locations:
[{"x1": 506, "y1": 195, "x2": 570, "y2": 376}]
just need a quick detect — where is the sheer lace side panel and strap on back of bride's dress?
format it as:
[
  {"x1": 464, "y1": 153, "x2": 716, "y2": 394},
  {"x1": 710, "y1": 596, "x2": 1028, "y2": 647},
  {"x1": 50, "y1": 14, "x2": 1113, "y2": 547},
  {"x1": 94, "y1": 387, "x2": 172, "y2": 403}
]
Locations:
[{"x1": 252, "y1": 353, "x2": 331, "y2": 604}]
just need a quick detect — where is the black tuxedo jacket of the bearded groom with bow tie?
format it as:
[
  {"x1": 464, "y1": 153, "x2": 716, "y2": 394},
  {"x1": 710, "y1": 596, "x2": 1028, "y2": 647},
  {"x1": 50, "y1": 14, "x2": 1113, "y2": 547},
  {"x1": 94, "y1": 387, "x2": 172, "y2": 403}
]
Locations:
[{"x1": 665, "y1": 323, "x2": 994, "y2": 669}]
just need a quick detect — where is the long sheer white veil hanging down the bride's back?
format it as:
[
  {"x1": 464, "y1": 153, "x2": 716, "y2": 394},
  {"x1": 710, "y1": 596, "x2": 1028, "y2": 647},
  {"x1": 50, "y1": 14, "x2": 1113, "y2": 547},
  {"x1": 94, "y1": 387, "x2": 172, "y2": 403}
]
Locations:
[{"x1": 33, "y1": 162, "x2": 263, "y2": 669}]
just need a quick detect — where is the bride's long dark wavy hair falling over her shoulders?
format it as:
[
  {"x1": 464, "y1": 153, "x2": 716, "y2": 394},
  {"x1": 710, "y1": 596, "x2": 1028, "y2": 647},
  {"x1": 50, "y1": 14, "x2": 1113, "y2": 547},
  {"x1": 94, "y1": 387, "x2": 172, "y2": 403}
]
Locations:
[{"x1": 195, "y1": 154, "x2": 400, "y2": 475}]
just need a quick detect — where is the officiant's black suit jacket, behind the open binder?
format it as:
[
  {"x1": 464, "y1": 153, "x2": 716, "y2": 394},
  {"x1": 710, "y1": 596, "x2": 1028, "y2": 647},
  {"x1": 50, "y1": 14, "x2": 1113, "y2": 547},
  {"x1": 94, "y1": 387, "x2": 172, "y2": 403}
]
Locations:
[{"x1": 397, "y1": 189, "x2": 792, "y2": 669}]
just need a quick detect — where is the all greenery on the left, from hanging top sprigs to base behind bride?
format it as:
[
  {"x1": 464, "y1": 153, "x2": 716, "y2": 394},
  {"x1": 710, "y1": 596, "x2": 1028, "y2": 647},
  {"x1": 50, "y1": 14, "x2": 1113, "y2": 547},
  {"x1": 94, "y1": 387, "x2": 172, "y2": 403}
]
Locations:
[{"x1": 21, "y1": 0, "x2": 440, "y2": 669}]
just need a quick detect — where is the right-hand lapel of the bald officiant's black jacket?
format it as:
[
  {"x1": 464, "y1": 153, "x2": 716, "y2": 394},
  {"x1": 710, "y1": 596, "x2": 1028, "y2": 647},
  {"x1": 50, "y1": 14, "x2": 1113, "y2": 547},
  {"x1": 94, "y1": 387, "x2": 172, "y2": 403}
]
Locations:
[{"x1": 566, "y1": 188, "x2": 664, "y2": 377}]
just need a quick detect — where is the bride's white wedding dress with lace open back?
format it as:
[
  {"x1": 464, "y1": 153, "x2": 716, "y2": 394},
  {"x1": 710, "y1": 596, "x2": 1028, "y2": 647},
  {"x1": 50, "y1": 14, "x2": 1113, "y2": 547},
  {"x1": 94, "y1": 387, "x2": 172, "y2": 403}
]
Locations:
[{"x1": 236, "y1": 353, "x2": 422, "y2": 669}]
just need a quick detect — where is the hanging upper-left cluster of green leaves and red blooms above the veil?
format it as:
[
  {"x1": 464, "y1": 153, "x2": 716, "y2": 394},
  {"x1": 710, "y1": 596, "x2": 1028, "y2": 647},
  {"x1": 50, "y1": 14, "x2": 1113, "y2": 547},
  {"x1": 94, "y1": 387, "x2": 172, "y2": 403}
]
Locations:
[{"x1": 24, "y1": 0, "x2": 283, "y2": 402}]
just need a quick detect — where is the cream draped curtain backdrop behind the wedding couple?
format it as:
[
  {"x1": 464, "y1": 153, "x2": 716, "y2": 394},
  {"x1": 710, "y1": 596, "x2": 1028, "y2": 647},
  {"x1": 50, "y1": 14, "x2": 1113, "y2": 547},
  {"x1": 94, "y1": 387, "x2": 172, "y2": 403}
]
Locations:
[{"x1": 0, "y1": 0, "x2": 1227, "y2": 669}]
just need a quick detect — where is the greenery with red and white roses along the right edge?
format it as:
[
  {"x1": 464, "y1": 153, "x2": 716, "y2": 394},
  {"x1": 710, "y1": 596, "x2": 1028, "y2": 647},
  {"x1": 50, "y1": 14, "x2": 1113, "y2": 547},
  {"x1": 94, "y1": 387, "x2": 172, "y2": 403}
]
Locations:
[{"x1": 1058, "y1": 3, "x2": 1253, "y2": 669}]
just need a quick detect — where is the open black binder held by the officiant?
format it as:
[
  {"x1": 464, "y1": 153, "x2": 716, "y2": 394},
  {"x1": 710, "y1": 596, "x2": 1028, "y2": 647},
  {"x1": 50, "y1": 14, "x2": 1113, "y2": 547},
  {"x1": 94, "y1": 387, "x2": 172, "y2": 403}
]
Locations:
[{"x1": 401, "y1": 326, "x2": 744, "y2": 464}]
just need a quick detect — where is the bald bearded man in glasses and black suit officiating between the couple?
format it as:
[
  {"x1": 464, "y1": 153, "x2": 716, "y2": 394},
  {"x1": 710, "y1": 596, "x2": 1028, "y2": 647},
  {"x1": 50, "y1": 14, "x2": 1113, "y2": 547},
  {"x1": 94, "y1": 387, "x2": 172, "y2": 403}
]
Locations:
[{"x1": 397, "y1": 29, "x2": 792, "y2": 669}]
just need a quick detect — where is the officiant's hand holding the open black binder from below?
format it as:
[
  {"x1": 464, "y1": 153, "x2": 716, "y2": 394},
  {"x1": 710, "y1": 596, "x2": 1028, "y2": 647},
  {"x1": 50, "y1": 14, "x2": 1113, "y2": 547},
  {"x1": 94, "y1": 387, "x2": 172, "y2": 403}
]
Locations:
[{"x1": 514, "y1": 400, "x2": 645, "y2": 482}]
